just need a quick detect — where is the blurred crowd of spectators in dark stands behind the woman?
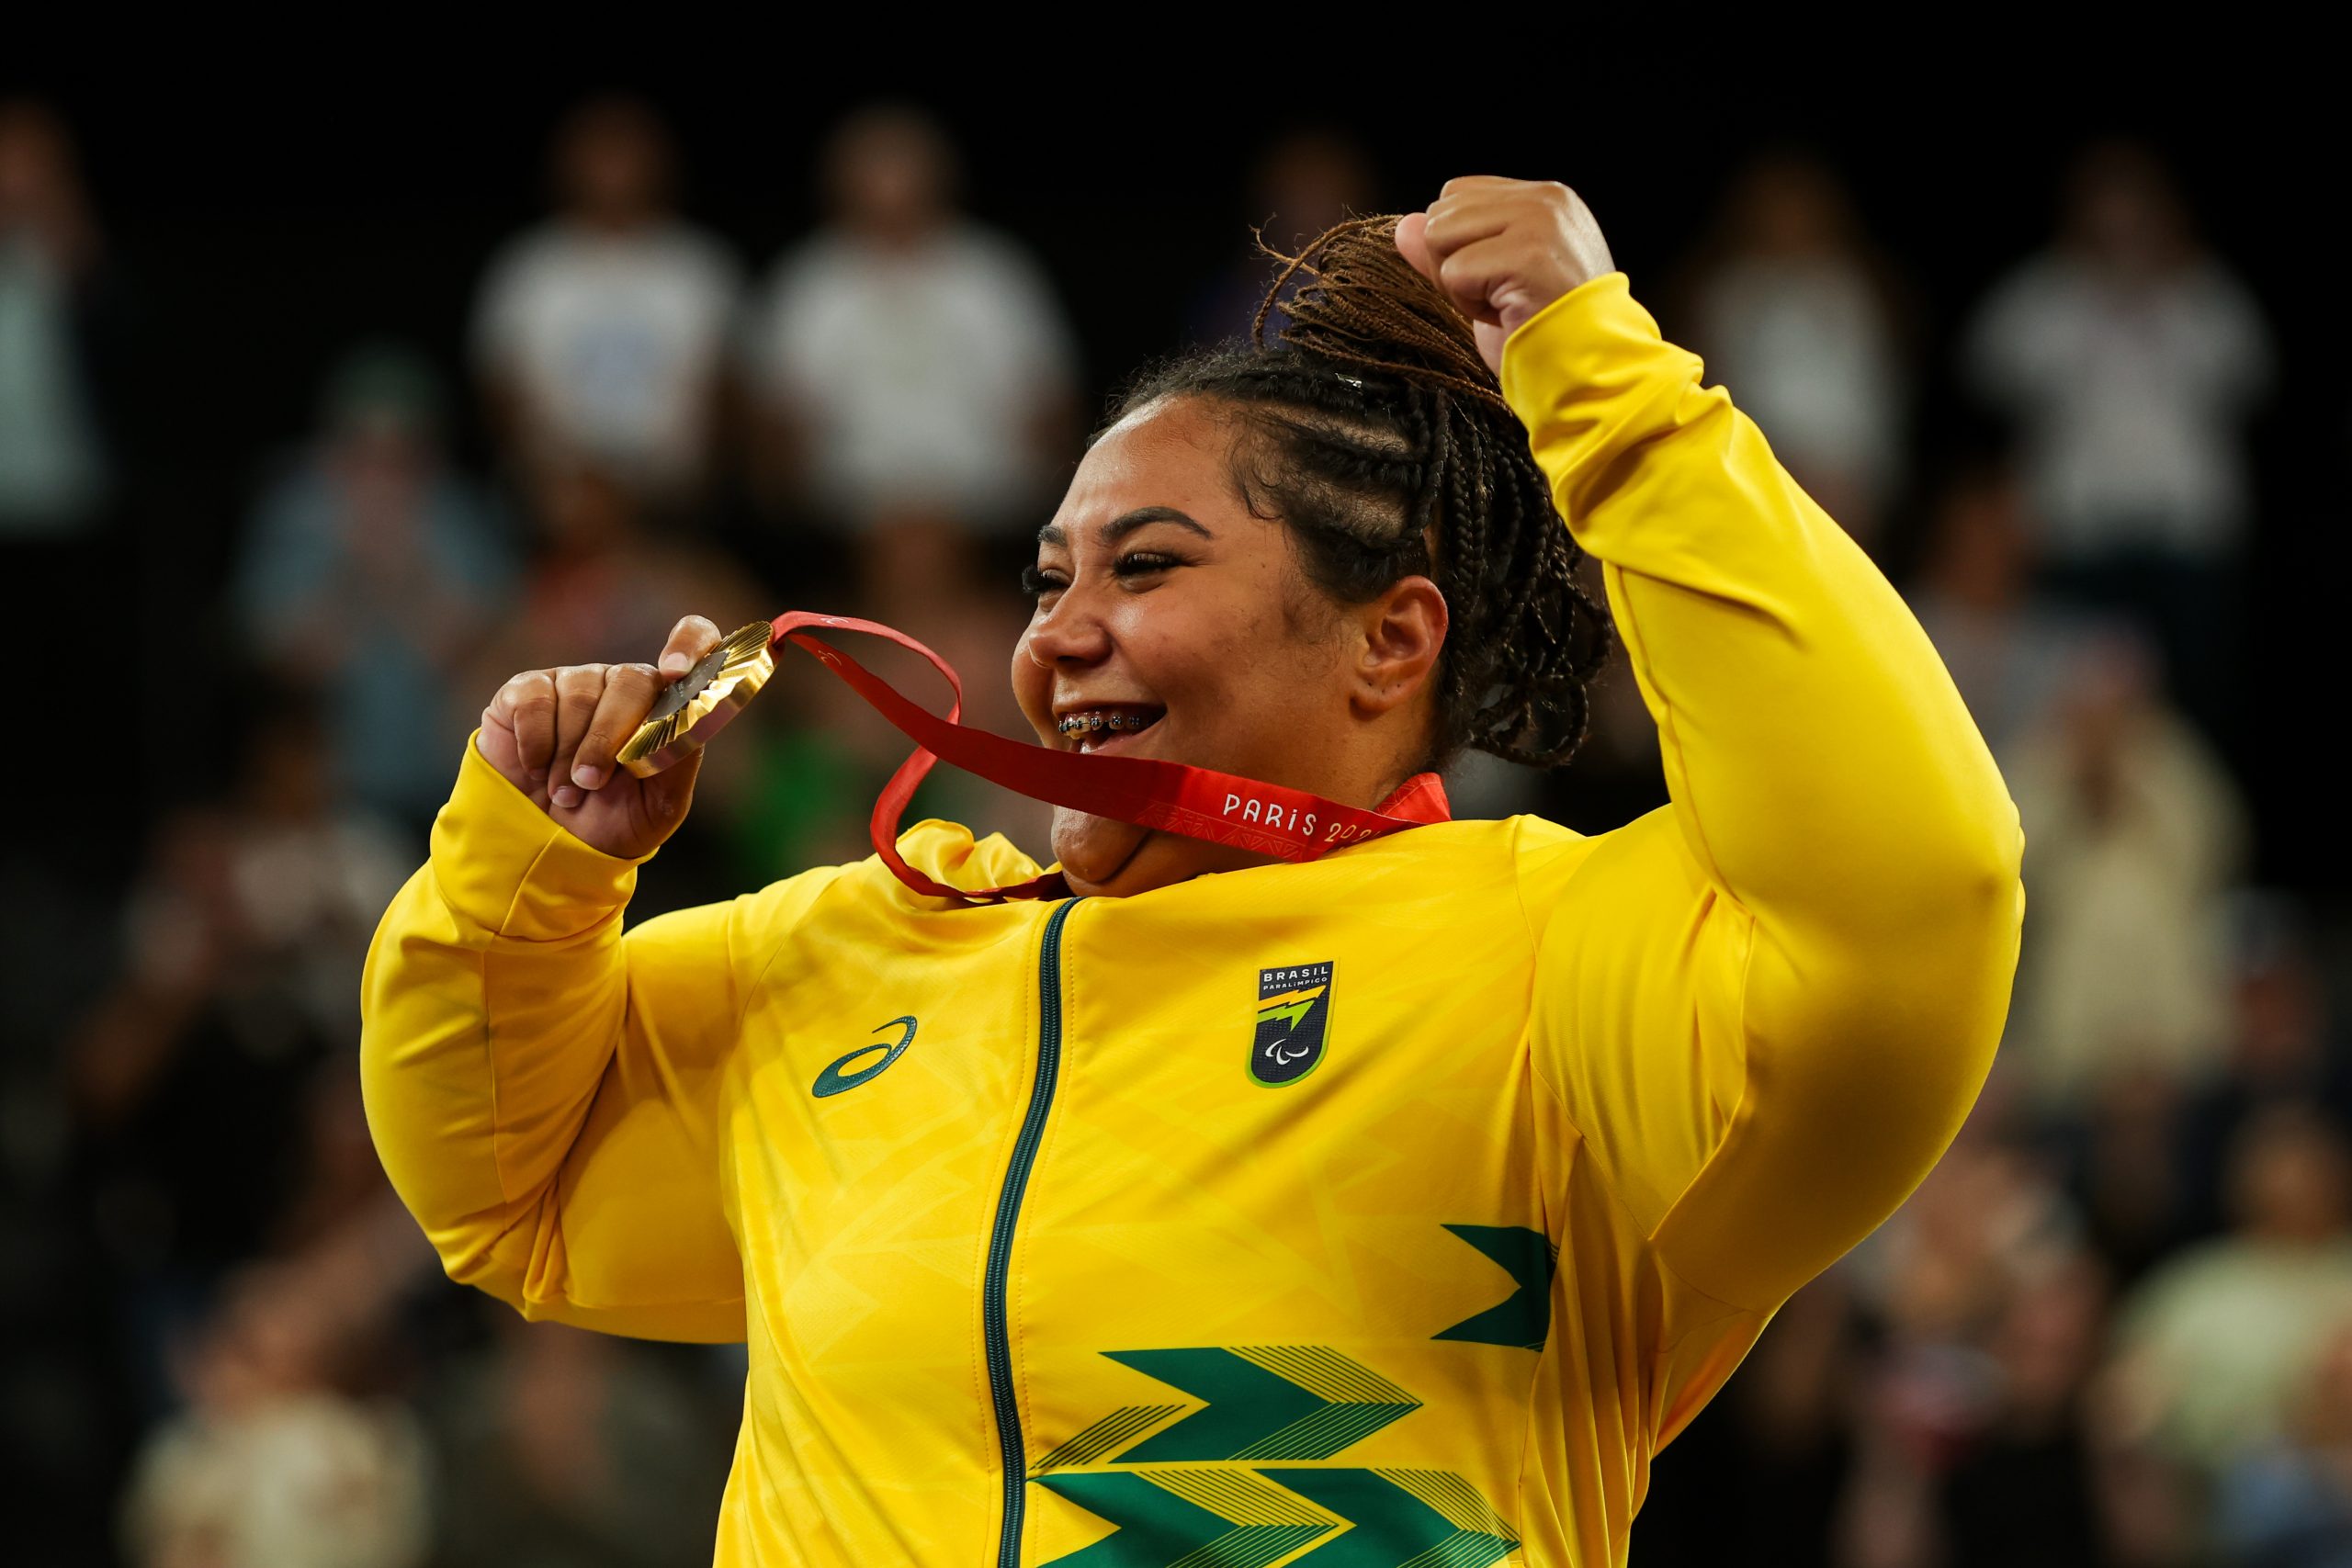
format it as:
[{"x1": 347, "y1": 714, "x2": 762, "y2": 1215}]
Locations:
[{"x1": 0, "y1": 70, "x2": 2352, "y2": 1568}]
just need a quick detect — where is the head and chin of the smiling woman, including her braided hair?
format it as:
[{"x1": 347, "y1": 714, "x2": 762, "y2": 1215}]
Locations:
[{"x1": 1013, "y1": 221, "x2": 1609, "y2": 894}]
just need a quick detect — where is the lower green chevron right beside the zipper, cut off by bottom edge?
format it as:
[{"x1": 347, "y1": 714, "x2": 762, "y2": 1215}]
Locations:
[{"x1": 1037, "y1": 1470, "x2": 1336, "y2": 1568}]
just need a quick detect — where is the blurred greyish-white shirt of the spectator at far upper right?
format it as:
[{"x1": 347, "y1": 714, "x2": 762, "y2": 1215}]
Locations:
[{"x1": 1966, "y1": 254, "x2": 2269, "y2": 559}]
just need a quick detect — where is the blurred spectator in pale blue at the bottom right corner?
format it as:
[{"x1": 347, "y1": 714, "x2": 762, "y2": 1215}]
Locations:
[{"x1": 2216, "y1": 1316, "x2": 2352, "y2": 1568}]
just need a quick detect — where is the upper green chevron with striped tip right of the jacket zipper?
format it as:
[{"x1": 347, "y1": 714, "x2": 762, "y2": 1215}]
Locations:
[{"x1": 1101, "y1": 1345, "x2": 1420, "y2": 1464}]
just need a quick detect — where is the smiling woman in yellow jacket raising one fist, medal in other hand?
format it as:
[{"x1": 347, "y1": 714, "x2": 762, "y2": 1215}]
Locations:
[{"x1": 365, "y1": 179, "x2": 2020, "y2": 1568}]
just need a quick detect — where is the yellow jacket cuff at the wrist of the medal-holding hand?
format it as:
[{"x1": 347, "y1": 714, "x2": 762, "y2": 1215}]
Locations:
[{"x1": 433, "y1": 731, "x2": 639, "y2": 942}]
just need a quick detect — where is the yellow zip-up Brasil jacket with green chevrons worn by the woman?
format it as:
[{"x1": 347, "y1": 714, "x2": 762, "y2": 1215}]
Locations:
[{"x1": 362, "y1": 275, "x2": 2023, "y2": 1568}]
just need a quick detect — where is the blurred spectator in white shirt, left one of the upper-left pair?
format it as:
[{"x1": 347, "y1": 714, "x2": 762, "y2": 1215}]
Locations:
[{"x1": 473, "y1": 98, "x2": 741, "y2": 501}]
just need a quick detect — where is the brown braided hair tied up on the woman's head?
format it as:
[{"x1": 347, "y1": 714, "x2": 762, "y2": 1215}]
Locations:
[{"x1": 1105, "y1": 219, "x2": 1611, "y2": 769}]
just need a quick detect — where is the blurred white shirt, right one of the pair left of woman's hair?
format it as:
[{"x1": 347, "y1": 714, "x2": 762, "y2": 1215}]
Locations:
[{"x1": 746, "y1": 226, "x2": 1077, "y2": 526}]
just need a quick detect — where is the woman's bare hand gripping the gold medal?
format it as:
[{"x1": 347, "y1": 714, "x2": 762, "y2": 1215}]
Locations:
[{"x1": 478, "y1": 616, "x2": 719, "y2": 861}]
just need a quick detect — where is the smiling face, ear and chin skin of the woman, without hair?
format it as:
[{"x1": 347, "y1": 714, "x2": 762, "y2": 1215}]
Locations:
[{"x1": 1012, "y1": 398, "x2": 1446, "y2": 894}]
